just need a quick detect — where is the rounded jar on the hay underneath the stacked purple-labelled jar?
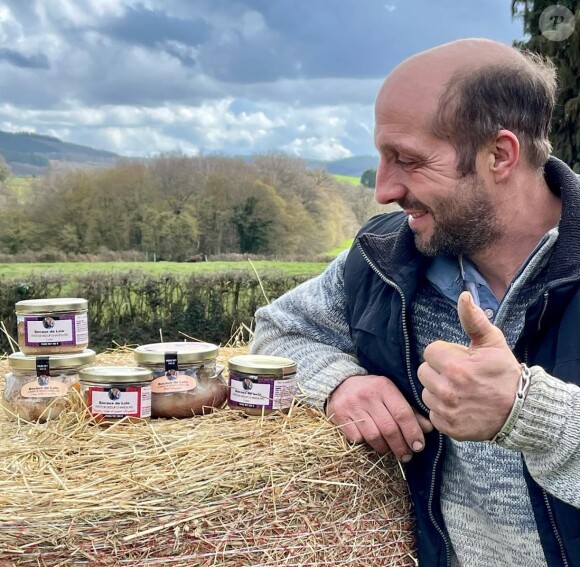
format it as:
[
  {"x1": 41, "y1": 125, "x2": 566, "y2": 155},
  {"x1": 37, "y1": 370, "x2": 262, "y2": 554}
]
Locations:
[{"x1": 2, "y1": 349, "x2": 96, "y2": 422}]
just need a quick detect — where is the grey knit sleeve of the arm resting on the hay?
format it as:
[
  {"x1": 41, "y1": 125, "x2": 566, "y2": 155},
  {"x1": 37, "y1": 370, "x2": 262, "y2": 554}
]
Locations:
[{"x1": 250, "y1": 251, "x2": 368, "y2": 408}]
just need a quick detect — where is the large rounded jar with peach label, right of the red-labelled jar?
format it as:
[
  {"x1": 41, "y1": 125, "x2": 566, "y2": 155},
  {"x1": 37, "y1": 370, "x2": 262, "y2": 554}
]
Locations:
[{"x1": 134, "y1": 342, "x2": 228, "y2": 418}]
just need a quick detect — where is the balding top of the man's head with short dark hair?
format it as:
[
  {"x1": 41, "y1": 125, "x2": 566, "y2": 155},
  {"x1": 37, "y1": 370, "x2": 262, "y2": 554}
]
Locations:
[{"x1": 376, "y1": 39, "x2": 556, "y2": 174}]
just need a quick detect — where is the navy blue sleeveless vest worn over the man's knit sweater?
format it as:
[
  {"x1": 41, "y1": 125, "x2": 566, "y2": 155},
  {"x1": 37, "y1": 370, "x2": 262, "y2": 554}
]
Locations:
[{"x1": 344, "y1": 158, "x2": 580, "y2": 567}]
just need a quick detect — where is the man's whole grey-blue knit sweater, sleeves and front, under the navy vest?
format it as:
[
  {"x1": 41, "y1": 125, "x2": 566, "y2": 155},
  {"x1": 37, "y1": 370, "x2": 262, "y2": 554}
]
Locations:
[{"x1": 252, "y1": 243, "x2": 580, "y2": 567}]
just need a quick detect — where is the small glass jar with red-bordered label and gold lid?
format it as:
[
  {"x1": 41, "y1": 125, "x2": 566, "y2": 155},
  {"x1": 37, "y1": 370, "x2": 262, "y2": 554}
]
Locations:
[{"x1": 80, "y1": 366, "x2": 153, "y2": 422}]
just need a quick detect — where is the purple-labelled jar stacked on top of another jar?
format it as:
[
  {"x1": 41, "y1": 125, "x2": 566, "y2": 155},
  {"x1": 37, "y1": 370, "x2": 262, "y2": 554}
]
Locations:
[{"x1": 15, "y1": 297, "x2": 89, "y2": 354}]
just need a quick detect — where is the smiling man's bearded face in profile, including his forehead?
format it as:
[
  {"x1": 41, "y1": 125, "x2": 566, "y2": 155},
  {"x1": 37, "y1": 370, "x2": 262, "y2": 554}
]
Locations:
[{"x1": 375, "y1": 67, "x2": 502, "y2": 256}]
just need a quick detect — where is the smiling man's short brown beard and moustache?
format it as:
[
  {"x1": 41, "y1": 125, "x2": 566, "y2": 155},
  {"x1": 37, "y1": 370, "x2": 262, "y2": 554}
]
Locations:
[{"x1": 399, "y1": 174, "x2": 502, "y2": 256}]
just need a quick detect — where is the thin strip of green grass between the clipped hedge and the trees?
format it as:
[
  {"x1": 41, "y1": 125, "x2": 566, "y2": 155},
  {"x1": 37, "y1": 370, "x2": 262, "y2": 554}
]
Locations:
[{"x1": 0, "y1": 260, "x2": 328, "y2": 278}]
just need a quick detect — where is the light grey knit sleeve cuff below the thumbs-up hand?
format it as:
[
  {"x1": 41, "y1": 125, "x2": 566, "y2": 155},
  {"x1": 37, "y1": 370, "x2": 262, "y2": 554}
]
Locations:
[{"x1": 498, "y1": 366, "x2": 580, "y2": 508}]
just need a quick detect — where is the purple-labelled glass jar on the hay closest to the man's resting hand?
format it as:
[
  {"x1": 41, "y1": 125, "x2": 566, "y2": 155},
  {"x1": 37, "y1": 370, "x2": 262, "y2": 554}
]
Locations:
[{"x1": 228, "y1": 354, "x2": 296, "y2": 415}]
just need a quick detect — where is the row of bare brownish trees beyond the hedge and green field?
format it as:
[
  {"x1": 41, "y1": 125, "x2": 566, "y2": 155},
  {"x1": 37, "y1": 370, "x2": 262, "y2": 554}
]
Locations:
[{"x1": 0, "y1": 153, "x2": 386, "y2": 261}]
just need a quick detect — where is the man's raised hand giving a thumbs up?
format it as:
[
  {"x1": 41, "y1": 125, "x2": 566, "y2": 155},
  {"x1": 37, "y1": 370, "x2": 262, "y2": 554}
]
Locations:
[{"x1": 418, "y1": 292, "x2": 521, "y2": 441}]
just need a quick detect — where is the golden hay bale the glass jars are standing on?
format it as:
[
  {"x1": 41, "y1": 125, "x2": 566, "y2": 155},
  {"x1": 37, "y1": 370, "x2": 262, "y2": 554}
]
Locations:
[{"x1": 0, "y1": 349, "x2": 417, "y2": 567}]
